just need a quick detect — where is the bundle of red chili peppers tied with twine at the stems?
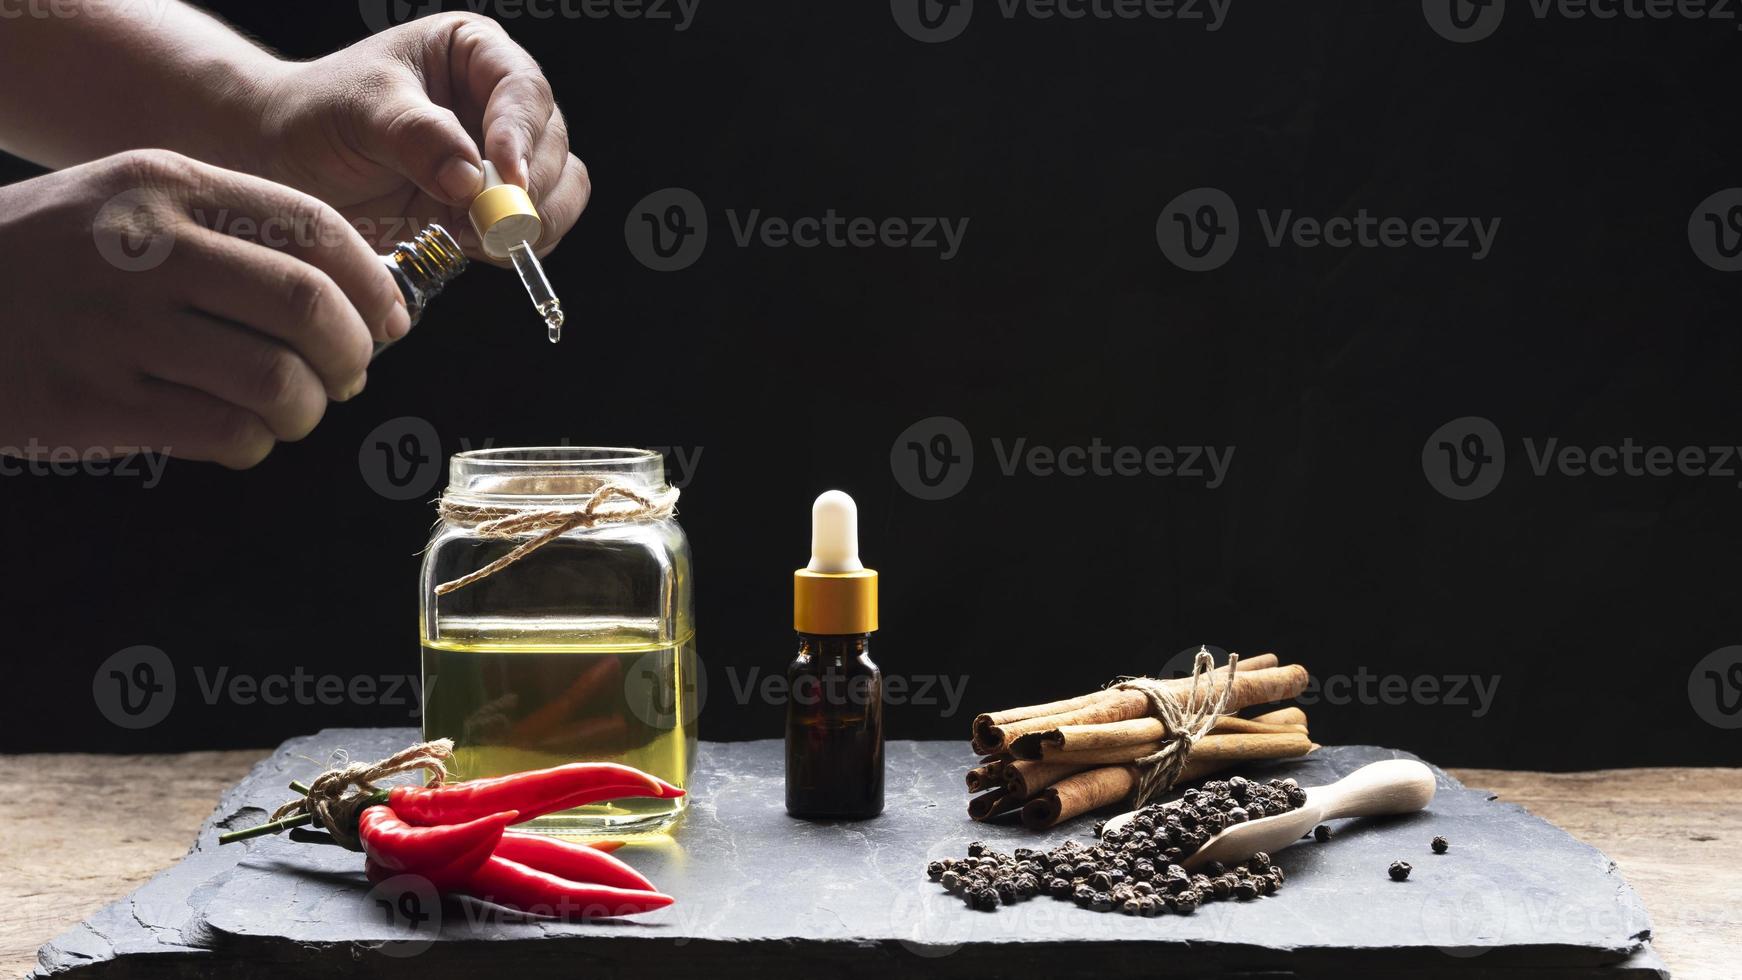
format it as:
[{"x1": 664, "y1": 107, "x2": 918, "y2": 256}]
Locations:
[{"x1": 218, "y1": 748, "x2": 683, "y2": 919}]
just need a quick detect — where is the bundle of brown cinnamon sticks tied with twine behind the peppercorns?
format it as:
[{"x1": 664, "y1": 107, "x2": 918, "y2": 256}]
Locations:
[{"x1": 967, "y1": 653, "x2": 1317, "y2": 830}]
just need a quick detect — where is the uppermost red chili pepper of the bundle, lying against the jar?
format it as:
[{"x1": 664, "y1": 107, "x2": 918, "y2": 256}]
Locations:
[{"x1": 387, "y1": 762, "x2": 683, "y2": 827}]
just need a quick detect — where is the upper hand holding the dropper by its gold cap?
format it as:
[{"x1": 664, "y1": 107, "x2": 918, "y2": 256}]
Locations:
[{"x1": 249, "y1": 14, "x2": 592, "y2": 258}]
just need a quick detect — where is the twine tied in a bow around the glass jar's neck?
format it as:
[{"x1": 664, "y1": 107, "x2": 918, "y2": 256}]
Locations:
[{"x1": 436, "y1": 484, "x2": 678, "y2": 595}]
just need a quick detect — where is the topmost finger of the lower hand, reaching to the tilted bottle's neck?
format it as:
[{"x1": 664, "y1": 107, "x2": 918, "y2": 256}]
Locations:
[{"x1": 182, "y1": 167, "x2": 411, "y2": 346}]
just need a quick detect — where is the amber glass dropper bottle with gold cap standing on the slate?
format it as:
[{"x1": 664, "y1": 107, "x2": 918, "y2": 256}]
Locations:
[{"x1": 786, "y1": 491, "x2": 883, "y2": 820}]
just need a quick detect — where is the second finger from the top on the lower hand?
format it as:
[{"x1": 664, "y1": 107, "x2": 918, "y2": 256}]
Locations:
[{"x1": 169, "y1": 232, "x2": 375, "y2": 400}]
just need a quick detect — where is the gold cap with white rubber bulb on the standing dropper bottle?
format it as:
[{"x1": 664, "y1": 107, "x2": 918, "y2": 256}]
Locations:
[{"x1": 793, "y1": 491, "x2": 876, "y2": 635}]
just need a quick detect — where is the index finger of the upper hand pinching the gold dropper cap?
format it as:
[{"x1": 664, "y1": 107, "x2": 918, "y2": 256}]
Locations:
[{"x1": 455, "y1": 19, "x2": 556, "y2": 188}]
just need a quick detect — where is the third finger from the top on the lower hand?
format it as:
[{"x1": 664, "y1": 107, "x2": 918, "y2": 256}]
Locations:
[{"x1": 141, "y1": 312, "x2": 327, "y2": 442}]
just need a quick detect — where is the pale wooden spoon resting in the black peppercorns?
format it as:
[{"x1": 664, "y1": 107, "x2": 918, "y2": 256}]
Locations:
[{"x1": 1106, "y1": 759, "x2": 1435, "y2": 872}]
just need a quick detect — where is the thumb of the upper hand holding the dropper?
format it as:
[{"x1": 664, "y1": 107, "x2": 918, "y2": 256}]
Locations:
[{"x1": 362, "y1": 85, "x2": 484, "y2": 207}]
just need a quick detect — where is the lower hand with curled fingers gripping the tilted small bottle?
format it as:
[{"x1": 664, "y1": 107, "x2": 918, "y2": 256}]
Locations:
[{"x1": 0, "y1": 150, "x2": 411, "y2": 468}]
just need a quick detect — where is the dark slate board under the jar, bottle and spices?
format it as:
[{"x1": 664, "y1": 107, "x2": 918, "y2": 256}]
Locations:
[{"x1": 37, "y1": 729, "x2": 1667, "y2": 980}]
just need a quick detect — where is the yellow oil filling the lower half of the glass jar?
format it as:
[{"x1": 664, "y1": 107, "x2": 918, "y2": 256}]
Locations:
[{"x1": 423, "y1": 620, "x2": 697, "y2": 837}]
